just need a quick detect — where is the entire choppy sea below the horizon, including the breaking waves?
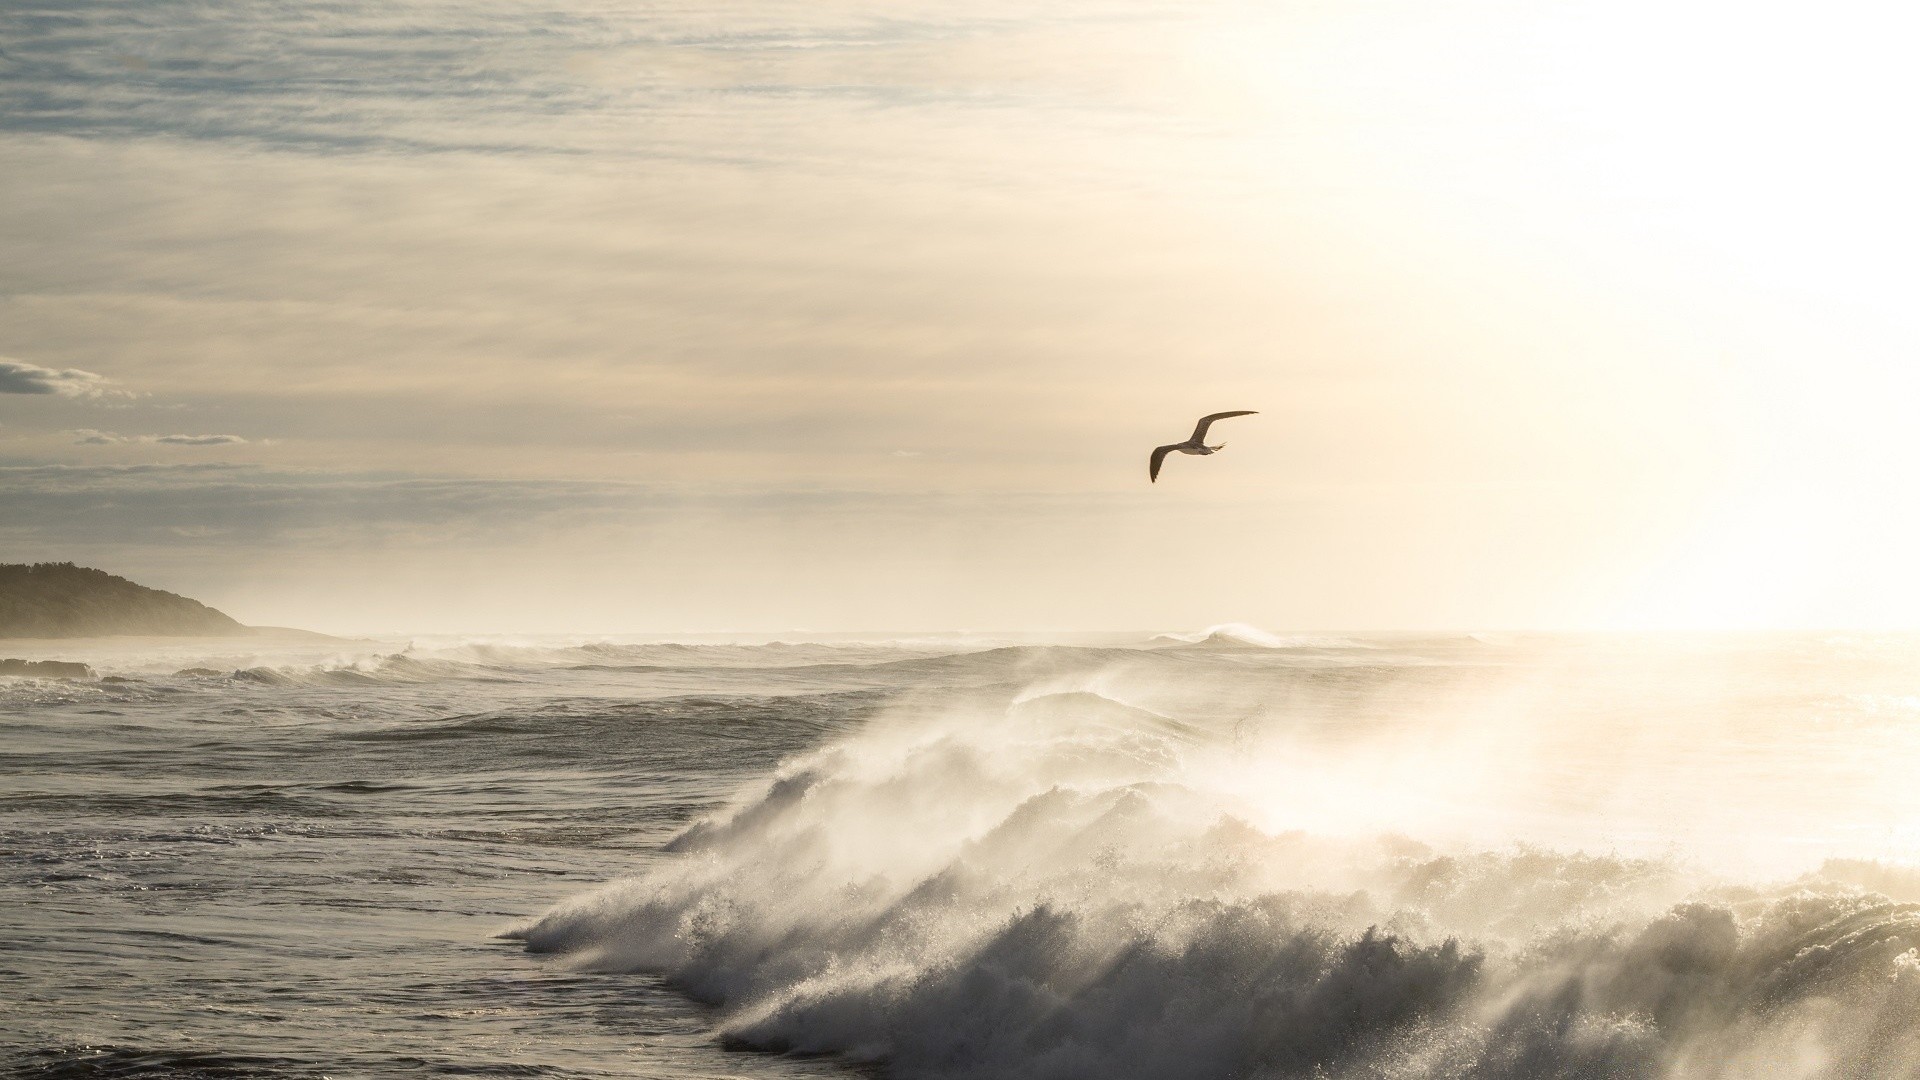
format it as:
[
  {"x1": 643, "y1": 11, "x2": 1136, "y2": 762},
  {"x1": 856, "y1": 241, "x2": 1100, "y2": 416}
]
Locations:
[{"x1": 0, "y1": 626, "x2": 1920, "y2": 1080}]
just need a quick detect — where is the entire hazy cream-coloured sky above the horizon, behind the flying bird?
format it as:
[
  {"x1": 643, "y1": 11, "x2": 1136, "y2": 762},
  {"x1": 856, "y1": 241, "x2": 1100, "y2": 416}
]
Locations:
[{"x1": 0, "y1": 0, "x2": 1920, "y2": 632}]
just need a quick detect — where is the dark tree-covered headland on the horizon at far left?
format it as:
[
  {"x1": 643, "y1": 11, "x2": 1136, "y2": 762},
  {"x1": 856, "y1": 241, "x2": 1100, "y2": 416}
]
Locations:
[{"x1": 0, "y1": 563, "x2": 255, "y2": 638}]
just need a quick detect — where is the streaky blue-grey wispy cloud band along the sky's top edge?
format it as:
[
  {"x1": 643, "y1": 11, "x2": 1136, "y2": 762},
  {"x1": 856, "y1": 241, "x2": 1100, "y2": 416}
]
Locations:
[{"x1": 0, "y1": 0, "x2": 1173, "y2": 158}]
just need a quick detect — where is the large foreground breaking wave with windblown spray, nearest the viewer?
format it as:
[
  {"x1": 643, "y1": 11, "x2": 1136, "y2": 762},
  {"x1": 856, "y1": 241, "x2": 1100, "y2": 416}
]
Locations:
[{"x1": 513, "y1": 692, "x2": 1920, "y2": 1080}]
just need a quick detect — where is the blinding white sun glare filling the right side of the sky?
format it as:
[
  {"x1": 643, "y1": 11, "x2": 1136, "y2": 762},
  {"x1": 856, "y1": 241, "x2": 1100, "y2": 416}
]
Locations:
[{"x1": 1188, "y1": 2, "x2": 1920, "y2": 626}]
